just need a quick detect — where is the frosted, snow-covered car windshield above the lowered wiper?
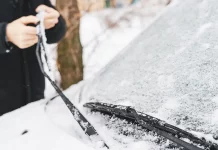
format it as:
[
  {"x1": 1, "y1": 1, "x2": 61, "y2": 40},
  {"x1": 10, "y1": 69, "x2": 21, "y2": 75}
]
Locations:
[{"x1": 83, "y1": 0, "x2": 218, "y2": 138}]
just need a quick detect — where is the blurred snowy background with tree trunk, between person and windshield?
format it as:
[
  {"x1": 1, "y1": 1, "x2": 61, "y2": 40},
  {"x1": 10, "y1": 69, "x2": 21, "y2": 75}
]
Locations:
[{"x1": 45, "y1": 0, "x2": 172, "y2": 97}]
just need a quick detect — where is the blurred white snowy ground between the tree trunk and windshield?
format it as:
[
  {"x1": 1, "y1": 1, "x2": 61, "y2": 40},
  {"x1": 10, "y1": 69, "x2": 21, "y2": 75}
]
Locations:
[{"x1": 80, "y1": 0, "x2": 167, "y2": 79}]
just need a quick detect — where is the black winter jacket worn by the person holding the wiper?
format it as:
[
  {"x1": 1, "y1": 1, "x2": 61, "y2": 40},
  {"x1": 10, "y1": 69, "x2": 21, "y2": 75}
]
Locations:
[{"x1": 0, "y1": 0, "x2": 66, "y2": 116}]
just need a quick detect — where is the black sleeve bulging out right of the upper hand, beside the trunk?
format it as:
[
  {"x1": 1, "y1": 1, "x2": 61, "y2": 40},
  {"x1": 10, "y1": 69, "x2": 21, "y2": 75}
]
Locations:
[{"x1": 45, "y1": 0, "x2": 66, "y2": 44}]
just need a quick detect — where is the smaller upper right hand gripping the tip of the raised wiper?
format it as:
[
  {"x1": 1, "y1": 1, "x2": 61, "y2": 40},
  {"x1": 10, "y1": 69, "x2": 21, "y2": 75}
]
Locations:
[{"x1": 36, "y1": 5, "x2": 60, "y2": 29}]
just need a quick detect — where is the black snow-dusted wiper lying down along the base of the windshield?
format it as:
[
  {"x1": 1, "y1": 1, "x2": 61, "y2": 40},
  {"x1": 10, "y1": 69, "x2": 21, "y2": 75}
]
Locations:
[{"x1": 84, "y1": 102, "x2": 218, "y2": 150}]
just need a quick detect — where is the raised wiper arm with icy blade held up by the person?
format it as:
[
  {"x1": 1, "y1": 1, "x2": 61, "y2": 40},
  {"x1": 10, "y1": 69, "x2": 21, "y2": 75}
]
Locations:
[{"x1": 36, "y1": 12, "x2": 109, "y2": 149}]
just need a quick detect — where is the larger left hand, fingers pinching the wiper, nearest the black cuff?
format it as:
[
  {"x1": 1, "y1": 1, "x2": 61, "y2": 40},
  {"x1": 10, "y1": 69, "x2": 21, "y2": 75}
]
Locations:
[{"x1": 6, "y1": 16, "x2": 39, "y2": 49}]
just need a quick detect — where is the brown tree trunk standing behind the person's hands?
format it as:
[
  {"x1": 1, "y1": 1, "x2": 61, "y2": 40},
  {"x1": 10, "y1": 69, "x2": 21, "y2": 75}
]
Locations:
[{"x1": 56, "y1": 0, "x2": 83, "y2": 89}]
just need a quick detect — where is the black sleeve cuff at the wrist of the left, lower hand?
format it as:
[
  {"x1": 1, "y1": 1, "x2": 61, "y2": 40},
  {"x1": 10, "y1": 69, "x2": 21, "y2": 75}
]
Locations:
[{"x1": 0, "y1": 23, "x2": 7, "y2": 54}]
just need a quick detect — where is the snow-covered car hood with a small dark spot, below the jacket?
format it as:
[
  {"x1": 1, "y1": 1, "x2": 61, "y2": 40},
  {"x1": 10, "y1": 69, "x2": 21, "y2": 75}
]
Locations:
[{"x1": 0, "y1": 100, "x2": 92, "y2": 150}]
